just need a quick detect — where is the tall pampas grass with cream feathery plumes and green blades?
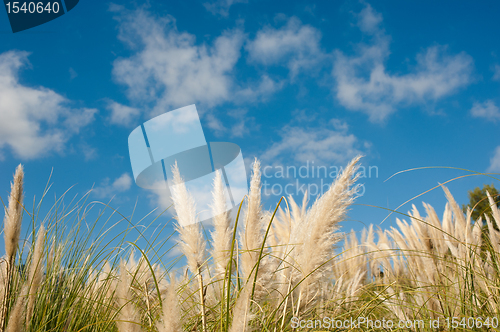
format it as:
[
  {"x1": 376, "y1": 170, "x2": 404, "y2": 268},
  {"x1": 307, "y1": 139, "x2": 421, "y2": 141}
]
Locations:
[{"x1": 0, "y1": 158, "x2": 500, "y2": 332}]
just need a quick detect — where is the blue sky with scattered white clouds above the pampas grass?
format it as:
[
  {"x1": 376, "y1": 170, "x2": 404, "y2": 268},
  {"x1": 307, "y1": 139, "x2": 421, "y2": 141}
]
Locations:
[{"x1": 0, "y1": 0, "x2": 500, "y2": 254}]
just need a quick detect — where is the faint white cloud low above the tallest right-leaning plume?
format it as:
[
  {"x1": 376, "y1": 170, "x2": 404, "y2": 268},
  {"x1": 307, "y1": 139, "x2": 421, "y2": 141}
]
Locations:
[{"x1": 261, "y1": 119, "x2": 362, "y2": 165}]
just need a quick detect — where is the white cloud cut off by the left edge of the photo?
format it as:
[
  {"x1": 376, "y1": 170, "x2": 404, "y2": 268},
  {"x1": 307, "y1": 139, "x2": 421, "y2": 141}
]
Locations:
[{"x1": 0, "y1": 51, "x2": 97, "y2": 159}]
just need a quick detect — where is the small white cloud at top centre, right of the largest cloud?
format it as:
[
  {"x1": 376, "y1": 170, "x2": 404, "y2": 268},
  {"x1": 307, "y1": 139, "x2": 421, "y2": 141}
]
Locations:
[{"x1": 246, "y1": 17, "x2": 326, "y2": 77}]
